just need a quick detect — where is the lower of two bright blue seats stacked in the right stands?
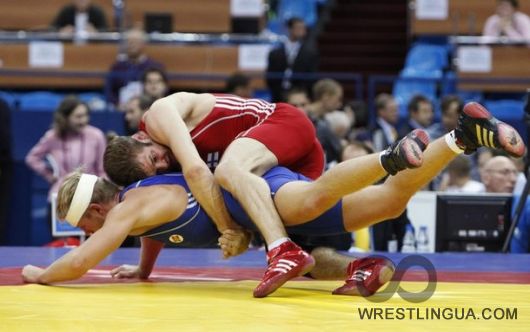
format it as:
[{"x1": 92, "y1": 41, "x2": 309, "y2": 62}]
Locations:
[{"x1": 392, "y1": 78, "x2": 437, "y2": 118}]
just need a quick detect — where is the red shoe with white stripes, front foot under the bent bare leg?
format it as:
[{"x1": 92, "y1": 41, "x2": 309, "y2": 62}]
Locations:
[{"x1": 254, "y1": 240, "x2": 315, "y2": 297}]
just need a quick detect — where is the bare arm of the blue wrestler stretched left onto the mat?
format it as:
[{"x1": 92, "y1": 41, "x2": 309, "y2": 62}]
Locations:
[{"x1": 22, "y1": 186, "x2": 187, "y2": 284}]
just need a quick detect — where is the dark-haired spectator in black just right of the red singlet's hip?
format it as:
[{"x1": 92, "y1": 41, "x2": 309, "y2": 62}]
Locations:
[{"x1": 307, "y1": 79, "x2": 343, "y2": 167}]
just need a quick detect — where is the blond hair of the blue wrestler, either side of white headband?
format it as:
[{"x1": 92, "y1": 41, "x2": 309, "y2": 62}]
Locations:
[{"x1": 57, "y1": 168, "x2": 120, "y2": 219}]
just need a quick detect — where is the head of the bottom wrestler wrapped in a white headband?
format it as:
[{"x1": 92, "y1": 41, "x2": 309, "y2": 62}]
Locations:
[{"x1": 57, "y1": 170, "x2": 120, "y2": 234}]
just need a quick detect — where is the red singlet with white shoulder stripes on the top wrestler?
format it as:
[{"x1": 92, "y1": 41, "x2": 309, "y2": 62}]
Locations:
[{"x1": 139, "y1": 94, "x2": 324, "y2": 179}]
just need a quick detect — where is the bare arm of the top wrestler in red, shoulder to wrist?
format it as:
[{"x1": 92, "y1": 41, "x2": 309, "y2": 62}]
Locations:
[{"x1": 145, "y1": 92, "x2": 239, "y2": 233}]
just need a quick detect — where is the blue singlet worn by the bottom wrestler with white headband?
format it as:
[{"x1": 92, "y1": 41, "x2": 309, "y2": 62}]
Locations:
[{"x1": 120, "y1": 166, "x2": 346, "y2": 248}]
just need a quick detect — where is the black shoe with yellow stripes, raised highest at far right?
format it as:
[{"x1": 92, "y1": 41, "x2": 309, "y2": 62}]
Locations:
[{"x1": 455, "y1": 102, "x2": 525, "y2": 157}]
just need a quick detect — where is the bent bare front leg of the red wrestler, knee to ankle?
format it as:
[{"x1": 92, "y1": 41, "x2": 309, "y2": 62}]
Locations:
[{"x1": 214, "y1": 137, "x2": 287, "y2": 244}]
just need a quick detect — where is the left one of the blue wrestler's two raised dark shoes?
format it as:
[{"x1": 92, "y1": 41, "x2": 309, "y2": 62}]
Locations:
[{"x1": 381, "y1": 129, "x2": 429, "y2": 175}]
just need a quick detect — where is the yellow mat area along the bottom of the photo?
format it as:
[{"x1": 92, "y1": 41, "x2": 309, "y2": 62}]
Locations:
[{"x1": 0, "y1": 281, "x2": 530, "y2": 332}]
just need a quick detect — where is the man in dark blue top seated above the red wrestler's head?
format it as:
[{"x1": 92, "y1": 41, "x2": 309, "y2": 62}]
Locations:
[{"x1": 106, "y1": 29, "x2": 164, "y2": 108}]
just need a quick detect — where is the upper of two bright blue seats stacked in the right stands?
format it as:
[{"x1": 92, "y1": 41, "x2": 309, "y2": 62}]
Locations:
[{"x1": 400, "y1": 44, "x2": 448, "y2": 79}]
